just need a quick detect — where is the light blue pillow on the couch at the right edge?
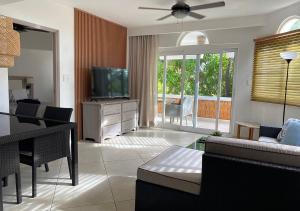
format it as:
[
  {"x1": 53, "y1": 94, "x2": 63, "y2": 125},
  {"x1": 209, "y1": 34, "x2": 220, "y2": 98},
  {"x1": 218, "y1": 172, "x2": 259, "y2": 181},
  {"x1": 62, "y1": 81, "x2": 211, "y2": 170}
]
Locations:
[{"x1": 280, "y1": 121, "x2": 300, "y2": 146}]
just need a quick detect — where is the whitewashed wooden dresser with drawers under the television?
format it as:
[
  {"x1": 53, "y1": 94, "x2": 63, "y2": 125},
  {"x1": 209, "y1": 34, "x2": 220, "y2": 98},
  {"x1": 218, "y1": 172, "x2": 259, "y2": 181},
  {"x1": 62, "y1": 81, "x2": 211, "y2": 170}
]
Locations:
[{"x1": 83, "y1": 99, "x2": 139, "y2": 143}]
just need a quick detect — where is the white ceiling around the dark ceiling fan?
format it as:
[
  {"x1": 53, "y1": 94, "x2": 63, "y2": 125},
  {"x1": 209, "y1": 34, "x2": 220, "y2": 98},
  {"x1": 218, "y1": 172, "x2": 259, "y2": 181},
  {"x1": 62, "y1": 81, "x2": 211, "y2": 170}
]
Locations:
[{"x1": 55, "y1": 0, "x2": 300, "y2": 27}]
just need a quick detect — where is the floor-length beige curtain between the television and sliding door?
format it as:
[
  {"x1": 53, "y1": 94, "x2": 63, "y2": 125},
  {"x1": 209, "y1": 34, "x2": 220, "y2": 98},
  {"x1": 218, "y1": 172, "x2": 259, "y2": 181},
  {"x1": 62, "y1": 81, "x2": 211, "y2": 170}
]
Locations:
[{"x1": 129, "y1": 35, "x2": 158, "y2": 127}]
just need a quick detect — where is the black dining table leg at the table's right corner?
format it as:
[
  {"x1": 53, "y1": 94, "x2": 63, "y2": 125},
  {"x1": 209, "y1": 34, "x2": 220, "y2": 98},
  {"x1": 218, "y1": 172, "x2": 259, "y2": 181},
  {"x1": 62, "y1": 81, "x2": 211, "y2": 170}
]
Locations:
[{"x1": 71, "y1": 126, "x2": 79, "y2": 186}]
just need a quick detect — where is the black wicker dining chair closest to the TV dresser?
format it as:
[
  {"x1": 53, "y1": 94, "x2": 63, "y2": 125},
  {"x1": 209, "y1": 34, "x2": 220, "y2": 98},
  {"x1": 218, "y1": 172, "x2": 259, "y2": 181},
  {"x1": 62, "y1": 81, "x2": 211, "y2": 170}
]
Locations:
[{"x1": 19, "y1": 106, "x2": 73, "y2": 197}]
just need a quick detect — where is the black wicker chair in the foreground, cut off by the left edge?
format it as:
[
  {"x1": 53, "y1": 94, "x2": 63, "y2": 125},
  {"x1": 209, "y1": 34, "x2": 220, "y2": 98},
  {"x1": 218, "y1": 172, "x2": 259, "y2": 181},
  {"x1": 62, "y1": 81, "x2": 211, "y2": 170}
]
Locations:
[{"x1": 0, "y1": 143, "x2": 22, "y2": 210}]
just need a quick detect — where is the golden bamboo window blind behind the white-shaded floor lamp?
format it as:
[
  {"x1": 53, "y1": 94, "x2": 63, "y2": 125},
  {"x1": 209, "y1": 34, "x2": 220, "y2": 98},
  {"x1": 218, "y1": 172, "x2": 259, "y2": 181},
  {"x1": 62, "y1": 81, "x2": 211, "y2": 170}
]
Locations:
[{"x1": 251, "y1": 30, "x2": 300, "y2": 106}]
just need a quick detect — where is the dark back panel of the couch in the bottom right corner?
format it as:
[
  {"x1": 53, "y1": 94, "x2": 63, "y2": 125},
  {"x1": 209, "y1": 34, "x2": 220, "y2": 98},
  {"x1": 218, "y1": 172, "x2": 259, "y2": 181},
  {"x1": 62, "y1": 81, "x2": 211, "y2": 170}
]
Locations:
[{"x1": 200, "y1": 153, "x2": 300, "y2": 211}]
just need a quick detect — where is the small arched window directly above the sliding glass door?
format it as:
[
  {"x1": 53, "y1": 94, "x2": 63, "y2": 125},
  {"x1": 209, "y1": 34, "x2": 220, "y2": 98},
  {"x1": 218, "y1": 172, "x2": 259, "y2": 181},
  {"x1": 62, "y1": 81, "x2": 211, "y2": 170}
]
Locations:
[{"x1": 178, "y1": 31, "x2": 209, "y2": 46}]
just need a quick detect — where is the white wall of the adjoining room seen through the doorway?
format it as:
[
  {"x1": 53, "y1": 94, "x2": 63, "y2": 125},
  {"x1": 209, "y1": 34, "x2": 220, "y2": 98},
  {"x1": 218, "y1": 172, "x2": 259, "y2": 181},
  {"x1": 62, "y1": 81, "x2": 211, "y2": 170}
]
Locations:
[{"x1": 8, "y1": 31, "x2": 54, "y2": 105}]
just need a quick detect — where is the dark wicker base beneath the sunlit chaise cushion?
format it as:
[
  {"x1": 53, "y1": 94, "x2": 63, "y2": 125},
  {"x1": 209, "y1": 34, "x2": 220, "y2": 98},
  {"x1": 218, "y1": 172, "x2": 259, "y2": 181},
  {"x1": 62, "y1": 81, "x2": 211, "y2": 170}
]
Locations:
[{"x1": 135, "y1": 180, "x2": 201, "y2": 211}]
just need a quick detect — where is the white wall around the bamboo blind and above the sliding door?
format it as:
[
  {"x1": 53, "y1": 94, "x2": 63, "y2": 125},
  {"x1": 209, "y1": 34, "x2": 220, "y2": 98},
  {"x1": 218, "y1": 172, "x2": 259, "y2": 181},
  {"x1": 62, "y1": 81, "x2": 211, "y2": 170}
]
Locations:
[{"x1": 129, "y1": 3, "x2": 300, "y2": 135}]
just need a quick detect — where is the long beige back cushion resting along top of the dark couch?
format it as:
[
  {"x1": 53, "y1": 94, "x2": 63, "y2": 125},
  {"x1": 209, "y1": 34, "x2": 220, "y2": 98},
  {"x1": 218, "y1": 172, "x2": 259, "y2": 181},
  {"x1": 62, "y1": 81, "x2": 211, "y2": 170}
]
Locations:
[{"x1": 205, "y1": 137, "x2": 300, "y2": 168}]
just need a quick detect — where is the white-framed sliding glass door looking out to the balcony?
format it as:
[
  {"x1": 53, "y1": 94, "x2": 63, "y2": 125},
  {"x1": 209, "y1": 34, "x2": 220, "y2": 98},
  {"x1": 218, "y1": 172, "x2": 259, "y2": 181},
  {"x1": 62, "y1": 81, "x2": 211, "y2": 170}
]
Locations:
[{"x1": 157, "y1": 49, "x2": 236, "y2": 133}]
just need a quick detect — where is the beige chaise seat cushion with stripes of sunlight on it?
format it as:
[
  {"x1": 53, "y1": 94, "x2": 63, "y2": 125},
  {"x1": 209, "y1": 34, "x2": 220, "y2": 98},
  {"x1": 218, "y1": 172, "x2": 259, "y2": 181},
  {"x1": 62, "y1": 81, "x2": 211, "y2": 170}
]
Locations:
[{"x1": 137, "y1": 146, "x2": 203, "y2": 194}]
